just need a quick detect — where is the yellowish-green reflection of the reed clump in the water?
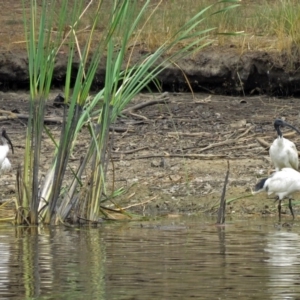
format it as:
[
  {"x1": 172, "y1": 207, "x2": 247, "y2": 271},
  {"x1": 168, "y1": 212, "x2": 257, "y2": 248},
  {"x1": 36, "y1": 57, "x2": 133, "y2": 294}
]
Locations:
[{"x1": 4, "y1": 228, "x2": 105, "y2": 299}]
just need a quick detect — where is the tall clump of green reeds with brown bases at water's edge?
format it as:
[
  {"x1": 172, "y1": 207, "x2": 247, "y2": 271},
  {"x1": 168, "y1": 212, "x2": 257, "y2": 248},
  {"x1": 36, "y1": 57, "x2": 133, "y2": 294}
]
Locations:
[{"x1": 17, "y1": 0, "x2": 238, "y2": 224}]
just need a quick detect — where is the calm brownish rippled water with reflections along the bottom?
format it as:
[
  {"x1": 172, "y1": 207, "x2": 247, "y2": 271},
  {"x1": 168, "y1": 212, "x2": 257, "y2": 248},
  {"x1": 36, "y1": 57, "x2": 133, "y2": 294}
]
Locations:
[{"x1": 0, "y1": 217, "x2": 300, "y2": 299}]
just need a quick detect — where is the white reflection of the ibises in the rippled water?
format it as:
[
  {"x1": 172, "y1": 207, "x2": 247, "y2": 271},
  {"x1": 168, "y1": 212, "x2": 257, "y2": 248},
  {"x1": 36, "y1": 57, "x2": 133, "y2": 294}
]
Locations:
[{"x1": 265, "y1": 231, "x2": 300, "y2": 299}]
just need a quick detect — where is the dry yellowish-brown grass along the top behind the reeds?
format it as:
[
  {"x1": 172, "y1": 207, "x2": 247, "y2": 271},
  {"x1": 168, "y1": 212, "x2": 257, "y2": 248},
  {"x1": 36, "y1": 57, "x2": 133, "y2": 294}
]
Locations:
[{"x1": 0, "y1": 0, "x2": 300, "y2": 55}]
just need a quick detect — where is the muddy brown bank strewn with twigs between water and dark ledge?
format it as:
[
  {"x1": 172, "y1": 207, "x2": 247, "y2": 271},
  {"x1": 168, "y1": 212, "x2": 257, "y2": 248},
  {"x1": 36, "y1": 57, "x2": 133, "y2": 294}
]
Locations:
[{"x1": 0, "y1": 90, "x2": 300, "y2": 220}]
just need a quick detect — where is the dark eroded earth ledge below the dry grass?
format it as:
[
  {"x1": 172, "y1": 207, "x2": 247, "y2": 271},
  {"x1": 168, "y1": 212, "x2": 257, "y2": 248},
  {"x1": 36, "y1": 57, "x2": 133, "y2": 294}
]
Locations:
[{"x1": 0, "y1": 46, "x2": 300, "y2": 97}]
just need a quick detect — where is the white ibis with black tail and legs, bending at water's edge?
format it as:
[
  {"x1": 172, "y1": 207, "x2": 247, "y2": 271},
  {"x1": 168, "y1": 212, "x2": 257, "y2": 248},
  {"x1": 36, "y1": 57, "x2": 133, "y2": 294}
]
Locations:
[{"x1": 252, "y1": 168, "x2": 300, "y2": 222}]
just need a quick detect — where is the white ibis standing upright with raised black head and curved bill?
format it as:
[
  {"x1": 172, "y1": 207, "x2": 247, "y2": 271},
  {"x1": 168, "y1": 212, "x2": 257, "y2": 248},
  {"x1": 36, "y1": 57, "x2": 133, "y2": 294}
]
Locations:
[{"x1": 269, "y1": 119, "x2": 300, "y2": 171}]
